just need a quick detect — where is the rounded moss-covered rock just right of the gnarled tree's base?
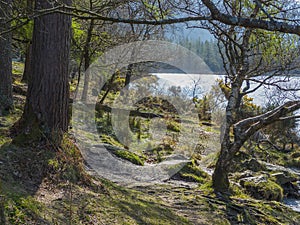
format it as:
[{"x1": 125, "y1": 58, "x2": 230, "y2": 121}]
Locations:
[{"x1": 240, "y1": 175, "x2": 283, "y2": 201}]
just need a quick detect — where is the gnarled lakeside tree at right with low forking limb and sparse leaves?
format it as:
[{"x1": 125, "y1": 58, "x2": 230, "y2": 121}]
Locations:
[{"x1": 205, "y1": 1, "x2": 300, "y2": 192}]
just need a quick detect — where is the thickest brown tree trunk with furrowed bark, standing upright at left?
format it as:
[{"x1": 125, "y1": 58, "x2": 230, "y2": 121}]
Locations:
[{"x1": 21, "y1": 0, "x2": 71, "y2": 137}]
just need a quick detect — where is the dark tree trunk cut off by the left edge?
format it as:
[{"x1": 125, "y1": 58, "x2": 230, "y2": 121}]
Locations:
[{"x1": 0, "y1": 0, "x2": 13, "y2": 115}]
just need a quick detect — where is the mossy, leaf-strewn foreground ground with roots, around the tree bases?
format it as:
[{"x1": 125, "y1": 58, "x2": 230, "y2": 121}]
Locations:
[{"x1": 0, "y1": 63, "x2": 300, "y2": 225}]
